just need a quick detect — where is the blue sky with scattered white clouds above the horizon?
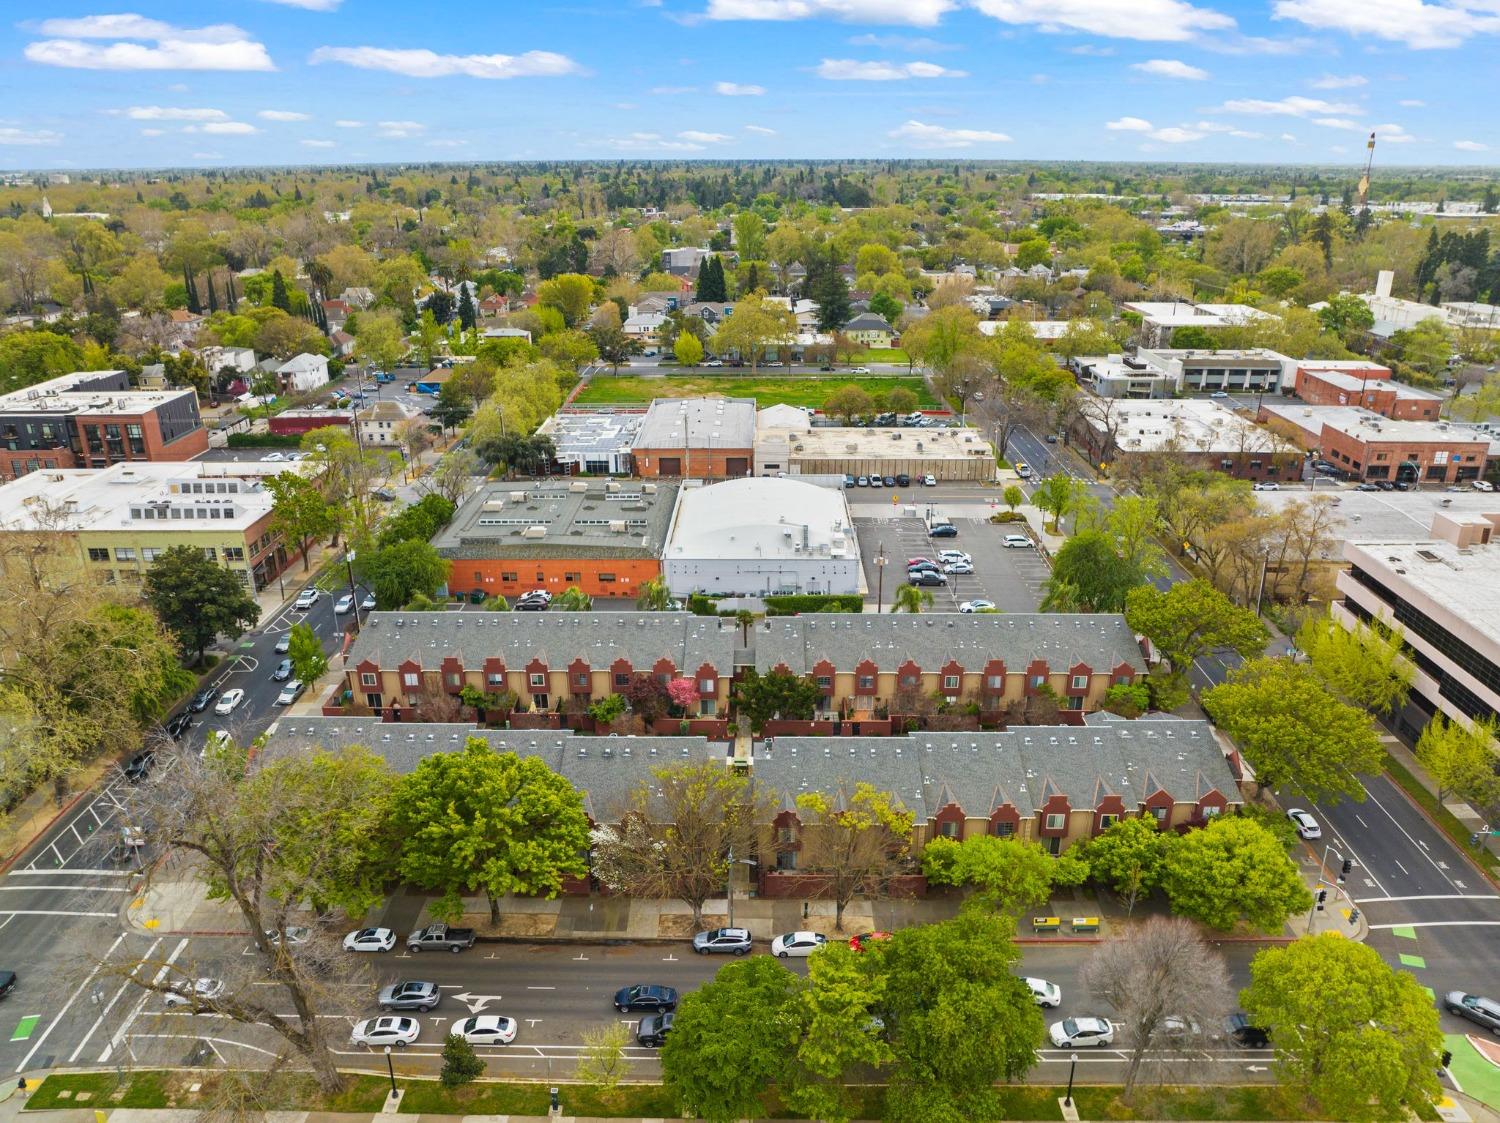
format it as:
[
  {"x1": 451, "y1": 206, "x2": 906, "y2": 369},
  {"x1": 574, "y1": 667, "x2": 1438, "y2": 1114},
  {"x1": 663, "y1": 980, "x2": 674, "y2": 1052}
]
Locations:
[{"x1": 0, "y1": 0, "x2": 1500, "y2": 168}]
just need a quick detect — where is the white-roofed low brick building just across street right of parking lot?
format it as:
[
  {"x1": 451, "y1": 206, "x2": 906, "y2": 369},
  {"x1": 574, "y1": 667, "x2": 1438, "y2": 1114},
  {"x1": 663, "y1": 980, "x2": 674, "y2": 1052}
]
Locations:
[{"x1": 1070, "y1": 397, "x2": 1304, "y2": 481}]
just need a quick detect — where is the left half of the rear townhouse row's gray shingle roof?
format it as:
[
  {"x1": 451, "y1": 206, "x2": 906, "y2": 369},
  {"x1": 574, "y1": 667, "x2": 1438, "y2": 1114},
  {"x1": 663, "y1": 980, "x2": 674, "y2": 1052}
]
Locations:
[{"x1": 348, "y1": 612, "x2": 740, "y2": 676}]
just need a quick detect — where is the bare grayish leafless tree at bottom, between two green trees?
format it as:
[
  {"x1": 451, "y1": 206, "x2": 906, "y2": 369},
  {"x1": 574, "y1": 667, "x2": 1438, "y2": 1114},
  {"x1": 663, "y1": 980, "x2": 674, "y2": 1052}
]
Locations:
[{"x1": 1079, "y1": 916, "x2": 1232, "y2": 1104}]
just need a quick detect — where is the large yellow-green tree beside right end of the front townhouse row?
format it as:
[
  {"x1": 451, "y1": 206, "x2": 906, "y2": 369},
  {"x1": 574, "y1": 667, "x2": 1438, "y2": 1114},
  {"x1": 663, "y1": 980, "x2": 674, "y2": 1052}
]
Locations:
[{"x1": 1203, "y1": 658, "x2": 1385, "y2": 802}]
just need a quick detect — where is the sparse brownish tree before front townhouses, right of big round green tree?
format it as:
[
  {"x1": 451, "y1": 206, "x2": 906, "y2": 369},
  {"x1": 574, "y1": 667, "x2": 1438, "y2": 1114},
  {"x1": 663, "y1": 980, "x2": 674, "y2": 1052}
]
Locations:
[{"x1": 591, "y1": 762, "x2": 768, "y2": 928}]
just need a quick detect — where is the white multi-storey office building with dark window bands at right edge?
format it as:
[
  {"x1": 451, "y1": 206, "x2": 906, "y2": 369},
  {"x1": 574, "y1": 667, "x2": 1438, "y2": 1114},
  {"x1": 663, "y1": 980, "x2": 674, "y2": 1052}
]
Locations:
[{"x1": 1334, "y1": 513, "x2": 1500, "y2": 733}]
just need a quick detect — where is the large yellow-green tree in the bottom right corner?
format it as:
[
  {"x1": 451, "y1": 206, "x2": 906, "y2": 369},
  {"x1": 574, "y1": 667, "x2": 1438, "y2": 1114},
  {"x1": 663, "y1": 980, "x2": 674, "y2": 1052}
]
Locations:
[{"x1": 1241, "y1": 933, "x2": 1443, "y2": 1123}]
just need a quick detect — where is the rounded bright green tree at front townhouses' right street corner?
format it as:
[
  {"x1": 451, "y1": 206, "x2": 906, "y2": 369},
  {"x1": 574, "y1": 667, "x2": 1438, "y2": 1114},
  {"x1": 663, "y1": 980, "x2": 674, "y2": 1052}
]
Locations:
[{"x1": 1161, "y1": 816, "x2": 1313, "y2": 933}]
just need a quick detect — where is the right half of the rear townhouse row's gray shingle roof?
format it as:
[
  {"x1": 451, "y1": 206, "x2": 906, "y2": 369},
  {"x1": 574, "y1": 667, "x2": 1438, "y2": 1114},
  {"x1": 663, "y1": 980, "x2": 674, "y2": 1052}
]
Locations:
[{"x1": 752, "y1": 612, "x2": 1146, "y2": 675}]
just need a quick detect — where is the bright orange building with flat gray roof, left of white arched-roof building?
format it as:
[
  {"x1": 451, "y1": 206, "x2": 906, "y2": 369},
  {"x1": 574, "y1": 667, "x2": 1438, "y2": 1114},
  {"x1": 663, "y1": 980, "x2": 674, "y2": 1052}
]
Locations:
[{"x1": 432, "y1": 480, "x2": 678, "y2": 597}]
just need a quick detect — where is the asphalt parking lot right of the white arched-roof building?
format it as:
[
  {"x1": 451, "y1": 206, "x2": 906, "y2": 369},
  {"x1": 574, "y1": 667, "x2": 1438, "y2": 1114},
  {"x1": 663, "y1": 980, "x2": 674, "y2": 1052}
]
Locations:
[{"x1": 854, "y1": 508, "x2": 1050, "y2": 612}]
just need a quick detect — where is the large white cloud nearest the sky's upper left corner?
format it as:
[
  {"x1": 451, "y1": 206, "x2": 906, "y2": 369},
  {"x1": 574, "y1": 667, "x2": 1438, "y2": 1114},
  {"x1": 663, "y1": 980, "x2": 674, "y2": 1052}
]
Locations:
[{"x1": 24, "y1": 13, "x2": 276, "y2": 70}]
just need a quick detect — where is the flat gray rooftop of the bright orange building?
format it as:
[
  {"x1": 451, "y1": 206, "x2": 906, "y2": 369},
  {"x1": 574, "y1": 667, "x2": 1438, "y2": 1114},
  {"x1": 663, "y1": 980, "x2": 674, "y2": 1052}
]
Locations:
[{"x1": 432, "y1": 480, "x2": 677, "y2": 559}]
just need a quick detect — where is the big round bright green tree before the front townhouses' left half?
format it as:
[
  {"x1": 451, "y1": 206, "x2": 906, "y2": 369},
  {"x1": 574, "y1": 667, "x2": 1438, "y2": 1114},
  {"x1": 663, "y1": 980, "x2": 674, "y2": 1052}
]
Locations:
[{"x1": 392, "y1": 738, "x2": 588, "y2": 925}]
